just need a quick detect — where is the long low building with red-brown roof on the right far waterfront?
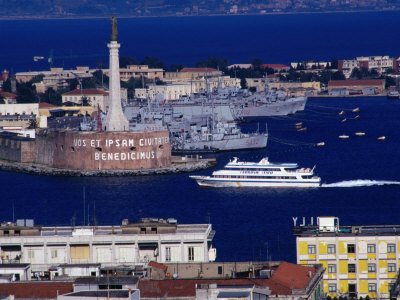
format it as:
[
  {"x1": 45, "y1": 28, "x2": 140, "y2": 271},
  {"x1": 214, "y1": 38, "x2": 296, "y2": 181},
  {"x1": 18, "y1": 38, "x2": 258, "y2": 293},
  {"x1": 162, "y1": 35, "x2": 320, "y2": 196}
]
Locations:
[{"x1": 328, "y1": 79, "x2": 385, "y2": 94}]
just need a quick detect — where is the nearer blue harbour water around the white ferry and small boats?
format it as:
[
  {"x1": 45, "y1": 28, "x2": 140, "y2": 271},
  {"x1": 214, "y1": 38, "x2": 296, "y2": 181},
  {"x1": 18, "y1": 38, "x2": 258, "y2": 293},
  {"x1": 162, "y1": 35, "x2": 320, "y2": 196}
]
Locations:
[{"x1": 0, "y1": 97, "x2": 400, "y2": 262}]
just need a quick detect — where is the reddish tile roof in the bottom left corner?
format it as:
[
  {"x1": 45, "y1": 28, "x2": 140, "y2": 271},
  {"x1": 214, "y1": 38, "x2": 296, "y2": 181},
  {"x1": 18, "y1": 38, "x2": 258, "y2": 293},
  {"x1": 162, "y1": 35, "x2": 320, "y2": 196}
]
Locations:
[{"x1": 0, "y1": 281, "x2": 73, "y2": 299}]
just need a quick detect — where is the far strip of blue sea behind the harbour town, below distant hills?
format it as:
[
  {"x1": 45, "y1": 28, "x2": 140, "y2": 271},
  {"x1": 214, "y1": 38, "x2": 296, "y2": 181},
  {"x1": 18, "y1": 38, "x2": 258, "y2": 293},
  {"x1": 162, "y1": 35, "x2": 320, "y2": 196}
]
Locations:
[{"x1": 0, "y1": 11, "x2": 400, "y2": 72}]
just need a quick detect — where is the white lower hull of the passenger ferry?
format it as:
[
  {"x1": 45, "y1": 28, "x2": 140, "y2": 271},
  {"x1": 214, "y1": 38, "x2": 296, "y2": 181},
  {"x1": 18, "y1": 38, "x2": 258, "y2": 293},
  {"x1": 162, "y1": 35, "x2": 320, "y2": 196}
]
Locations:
[{"x1": 190, "y1": 176, "x2": 321, "y2": 188}]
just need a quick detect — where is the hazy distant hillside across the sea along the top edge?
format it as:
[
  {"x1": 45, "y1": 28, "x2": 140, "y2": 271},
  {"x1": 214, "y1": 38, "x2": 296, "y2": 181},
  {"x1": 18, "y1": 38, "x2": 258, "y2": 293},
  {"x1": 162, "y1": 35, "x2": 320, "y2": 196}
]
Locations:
[{"x1": 0, "y1": 0, "x2": 400, "y2": 18}]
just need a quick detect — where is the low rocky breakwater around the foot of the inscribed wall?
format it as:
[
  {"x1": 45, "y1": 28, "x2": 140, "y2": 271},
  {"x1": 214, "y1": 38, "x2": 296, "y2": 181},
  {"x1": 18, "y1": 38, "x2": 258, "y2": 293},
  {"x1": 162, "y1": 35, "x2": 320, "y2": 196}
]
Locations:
[{"x1": 0, "y1": 157, "x2": 216, "y2": 177}]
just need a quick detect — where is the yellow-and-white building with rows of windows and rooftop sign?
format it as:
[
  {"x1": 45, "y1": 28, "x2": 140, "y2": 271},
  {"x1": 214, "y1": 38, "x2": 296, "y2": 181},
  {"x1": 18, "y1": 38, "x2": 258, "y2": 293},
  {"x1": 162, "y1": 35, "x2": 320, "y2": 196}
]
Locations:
[{"x1": 293, "y1": 217, "x2": 400, "y2": 299}]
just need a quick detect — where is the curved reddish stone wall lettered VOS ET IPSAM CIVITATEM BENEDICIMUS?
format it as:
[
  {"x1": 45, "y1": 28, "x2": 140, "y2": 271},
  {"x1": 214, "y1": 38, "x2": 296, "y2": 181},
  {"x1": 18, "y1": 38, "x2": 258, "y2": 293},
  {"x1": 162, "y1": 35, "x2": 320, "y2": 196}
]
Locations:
[{"x1": 53, "y1": 131, "x2": 171, "y2": 170}]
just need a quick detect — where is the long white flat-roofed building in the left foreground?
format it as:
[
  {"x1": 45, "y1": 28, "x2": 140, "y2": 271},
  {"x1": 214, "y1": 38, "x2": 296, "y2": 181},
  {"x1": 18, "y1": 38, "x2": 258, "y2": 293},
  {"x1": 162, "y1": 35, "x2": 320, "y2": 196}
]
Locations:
[{"x1": 0, "y1": 219, "x2": 216, "y2": 272}]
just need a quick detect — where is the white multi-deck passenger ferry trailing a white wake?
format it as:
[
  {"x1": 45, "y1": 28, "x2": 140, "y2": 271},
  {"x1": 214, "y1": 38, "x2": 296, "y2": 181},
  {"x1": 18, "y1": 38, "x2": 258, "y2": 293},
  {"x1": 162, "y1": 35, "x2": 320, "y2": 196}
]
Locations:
[{"x1": 189, "y1": 157, "x2": 321, "y2": 187}]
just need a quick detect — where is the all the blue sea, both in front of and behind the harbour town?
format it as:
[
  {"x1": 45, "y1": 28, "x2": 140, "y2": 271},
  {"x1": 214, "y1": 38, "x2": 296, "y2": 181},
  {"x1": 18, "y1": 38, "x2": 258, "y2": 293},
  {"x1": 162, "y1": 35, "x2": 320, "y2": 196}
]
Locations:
[{"x1": 0, "y1": 12, "x2": 400, "y2": 262}]
